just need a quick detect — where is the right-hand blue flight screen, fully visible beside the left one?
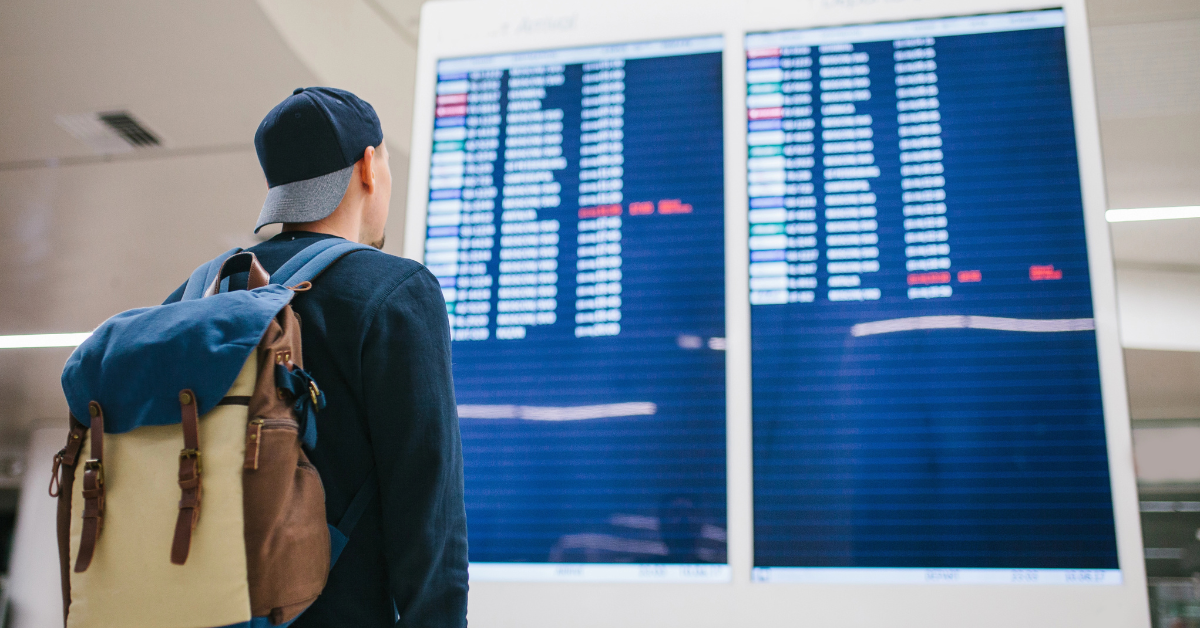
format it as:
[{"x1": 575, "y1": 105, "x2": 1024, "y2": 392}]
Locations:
[{"x1": 746, "y1": 11, "x2": 1121, "y2": 584}]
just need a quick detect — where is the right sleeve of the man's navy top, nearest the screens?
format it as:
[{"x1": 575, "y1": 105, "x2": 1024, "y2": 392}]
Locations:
[{"x1": 362, "y1": 268, "x2": 467, "y2": 628}]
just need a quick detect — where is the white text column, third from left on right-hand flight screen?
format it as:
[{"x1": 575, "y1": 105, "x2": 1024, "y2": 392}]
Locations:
[{"x1": 820, "y1": 43, "x2": 881, "y2": 301}]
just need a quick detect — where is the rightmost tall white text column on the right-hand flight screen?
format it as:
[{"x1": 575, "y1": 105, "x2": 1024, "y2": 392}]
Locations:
[{"x1": 893, "y1": 37, "x2": 954, "y2": 299}]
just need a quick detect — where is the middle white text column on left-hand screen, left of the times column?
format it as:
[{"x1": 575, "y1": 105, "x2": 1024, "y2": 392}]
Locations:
[{"x1": 496, "y1": 65, "x2": 566, "y2": 340}]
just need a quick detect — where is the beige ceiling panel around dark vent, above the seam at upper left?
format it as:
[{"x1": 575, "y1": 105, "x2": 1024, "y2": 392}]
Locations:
[{"x1": 0, "y1": 0, "x2": 316, "y2": 165}]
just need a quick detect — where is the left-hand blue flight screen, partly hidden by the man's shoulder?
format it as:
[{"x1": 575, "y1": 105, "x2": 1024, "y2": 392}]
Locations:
[{"x1": 425, "y1": 37, "x2": 728, "y2": 581}]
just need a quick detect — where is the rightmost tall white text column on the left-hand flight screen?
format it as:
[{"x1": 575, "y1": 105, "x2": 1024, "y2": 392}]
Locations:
[{"x1": 575, "y1": 59, "x2": 625, "y2": 337}]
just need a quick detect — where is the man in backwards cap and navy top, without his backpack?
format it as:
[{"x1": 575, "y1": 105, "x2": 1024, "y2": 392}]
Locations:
[{"x1": 167, "y1": 88, "x2": 467, "y2": 628}]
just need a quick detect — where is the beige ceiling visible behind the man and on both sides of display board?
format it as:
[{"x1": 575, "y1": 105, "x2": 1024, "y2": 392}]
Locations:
[{"x1": 0, "y1": 0, "x2": 1200, "y2": 439}]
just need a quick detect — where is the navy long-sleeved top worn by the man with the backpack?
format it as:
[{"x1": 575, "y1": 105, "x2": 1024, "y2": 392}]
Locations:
[{"x1": 167, "y1": 232, "x2": 467, "y2": 628}]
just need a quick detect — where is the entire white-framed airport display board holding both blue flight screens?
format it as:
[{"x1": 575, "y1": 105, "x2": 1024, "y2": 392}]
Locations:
[{"x1": 415, "y1": 0, "x2": 1148, "y2": 628}]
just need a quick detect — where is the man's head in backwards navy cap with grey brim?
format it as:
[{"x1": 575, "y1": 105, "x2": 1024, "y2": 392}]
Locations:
[{"x1": 254, "y1": 88, "x2": 391, "y2": 247}]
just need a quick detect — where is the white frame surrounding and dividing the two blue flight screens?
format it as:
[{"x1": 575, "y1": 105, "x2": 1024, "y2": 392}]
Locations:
[{"x1": 404, "y1": 0, "x2": 1150, "y2": 628}]
